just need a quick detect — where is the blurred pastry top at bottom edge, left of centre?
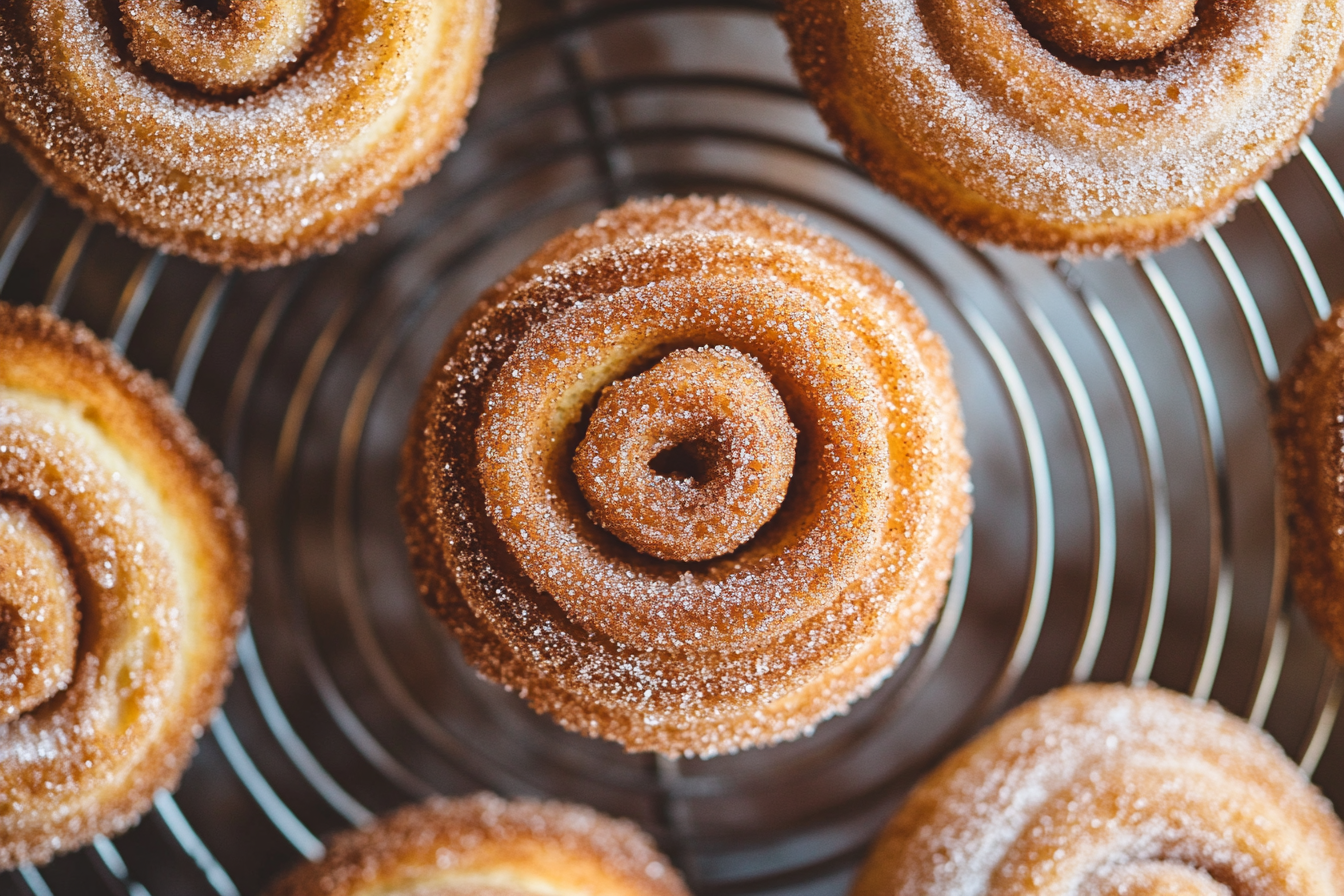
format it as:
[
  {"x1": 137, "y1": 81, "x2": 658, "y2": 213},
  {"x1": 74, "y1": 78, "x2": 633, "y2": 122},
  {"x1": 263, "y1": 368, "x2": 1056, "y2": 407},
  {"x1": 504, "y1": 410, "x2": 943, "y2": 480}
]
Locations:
[{"x1": 267, "y1": 794, "x2": 688, "y2": 896}]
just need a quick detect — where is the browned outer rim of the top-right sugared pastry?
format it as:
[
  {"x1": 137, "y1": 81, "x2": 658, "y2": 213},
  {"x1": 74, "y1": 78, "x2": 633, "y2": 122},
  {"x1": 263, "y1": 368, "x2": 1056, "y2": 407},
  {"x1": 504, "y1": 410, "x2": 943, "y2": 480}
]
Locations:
[{"x1": 780, "y1": 0, "x2": 1344, "y2": 258}]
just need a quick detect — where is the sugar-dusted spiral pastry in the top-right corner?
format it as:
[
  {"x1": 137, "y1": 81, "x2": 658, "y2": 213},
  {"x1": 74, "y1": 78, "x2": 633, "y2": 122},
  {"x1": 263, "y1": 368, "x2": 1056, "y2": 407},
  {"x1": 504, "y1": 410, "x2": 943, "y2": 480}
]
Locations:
[{"x1": 781, "y1": 0, "x2": 1344, "y2": 255}]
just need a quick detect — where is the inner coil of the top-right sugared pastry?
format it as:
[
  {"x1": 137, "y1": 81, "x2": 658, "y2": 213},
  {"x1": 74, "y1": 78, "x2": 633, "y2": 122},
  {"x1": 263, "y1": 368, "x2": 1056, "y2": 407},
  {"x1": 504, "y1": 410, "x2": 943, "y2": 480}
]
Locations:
[{"x1": 1013, "y1": 0, "x2": 1196, "y2": 62}]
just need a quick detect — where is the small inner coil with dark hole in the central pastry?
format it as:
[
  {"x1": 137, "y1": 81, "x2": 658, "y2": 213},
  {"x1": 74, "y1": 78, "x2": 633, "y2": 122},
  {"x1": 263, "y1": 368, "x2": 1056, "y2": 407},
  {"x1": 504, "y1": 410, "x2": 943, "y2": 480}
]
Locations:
[{"x1": 574, "y1": 347, "x2": 797, "y2": 562}]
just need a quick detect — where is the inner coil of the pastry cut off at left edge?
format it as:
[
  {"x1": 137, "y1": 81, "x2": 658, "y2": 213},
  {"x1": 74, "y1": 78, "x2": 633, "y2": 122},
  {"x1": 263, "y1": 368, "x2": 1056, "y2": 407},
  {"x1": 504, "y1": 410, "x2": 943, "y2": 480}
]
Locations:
[{"x1": 0, "y1": 497, "x2": 79, "y2": 723}]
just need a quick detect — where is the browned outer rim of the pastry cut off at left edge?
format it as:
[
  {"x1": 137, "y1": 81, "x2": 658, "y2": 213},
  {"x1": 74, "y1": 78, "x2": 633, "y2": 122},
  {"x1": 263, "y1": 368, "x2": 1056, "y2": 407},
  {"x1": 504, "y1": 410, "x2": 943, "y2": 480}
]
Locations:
[{"x1": 0, "y1": 304, "x2": 251, "y2": 865}]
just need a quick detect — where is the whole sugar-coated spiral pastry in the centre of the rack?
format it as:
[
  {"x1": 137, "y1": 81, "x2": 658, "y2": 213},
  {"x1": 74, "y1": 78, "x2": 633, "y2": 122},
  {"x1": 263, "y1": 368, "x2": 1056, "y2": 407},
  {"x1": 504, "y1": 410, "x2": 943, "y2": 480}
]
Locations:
[{"x1": 402, "y1": 199, "x2": 969, "y2": 755}]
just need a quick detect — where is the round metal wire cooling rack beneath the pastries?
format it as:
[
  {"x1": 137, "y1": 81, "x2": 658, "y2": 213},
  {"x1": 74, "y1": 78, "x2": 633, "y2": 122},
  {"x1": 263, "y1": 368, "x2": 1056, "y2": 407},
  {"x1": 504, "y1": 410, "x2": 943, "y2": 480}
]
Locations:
[{"x1": 0, "y1": 0, "x2": 1344, "y2": 896}]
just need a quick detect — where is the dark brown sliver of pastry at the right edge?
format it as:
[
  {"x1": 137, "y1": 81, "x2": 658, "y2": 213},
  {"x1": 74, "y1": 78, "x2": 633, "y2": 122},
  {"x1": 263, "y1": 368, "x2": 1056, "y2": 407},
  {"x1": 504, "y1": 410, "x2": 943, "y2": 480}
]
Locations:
[{"x1": 1274, "y1": 306, "x2": 1344, "y2": 664}]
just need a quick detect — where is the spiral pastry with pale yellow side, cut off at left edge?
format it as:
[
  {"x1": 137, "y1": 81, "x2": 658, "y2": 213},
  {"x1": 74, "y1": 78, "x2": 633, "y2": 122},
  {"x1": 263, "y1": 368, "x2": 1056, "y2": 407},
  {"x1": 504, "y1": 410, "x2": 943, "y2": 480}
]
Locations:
[{"x1": 0, "y1": 305, "x2": 249, "y2": 868}]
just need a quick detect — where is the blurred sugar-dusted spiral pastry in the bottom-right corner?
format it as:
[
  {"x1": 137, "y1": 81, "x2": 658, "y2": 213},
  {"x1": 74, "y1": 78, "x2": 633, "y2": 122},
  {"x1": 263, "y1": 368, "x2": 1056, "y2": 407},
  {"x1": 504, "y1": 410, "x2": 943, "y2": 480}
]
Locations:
[{"x1": 852, "y1": 685, "x2": 1344, "y2": 896}]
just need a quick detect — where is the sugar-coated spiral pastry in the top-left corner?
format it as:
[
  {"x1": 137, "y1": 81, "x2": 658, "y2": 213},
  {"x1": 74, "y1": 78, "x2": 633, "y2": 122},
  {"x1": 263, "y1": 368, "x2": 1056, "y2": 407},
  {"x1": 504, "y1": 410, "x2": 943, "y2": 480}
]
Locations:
[{"x1": 0, "y1": 0, "x2": 495, "y2": 267}]
